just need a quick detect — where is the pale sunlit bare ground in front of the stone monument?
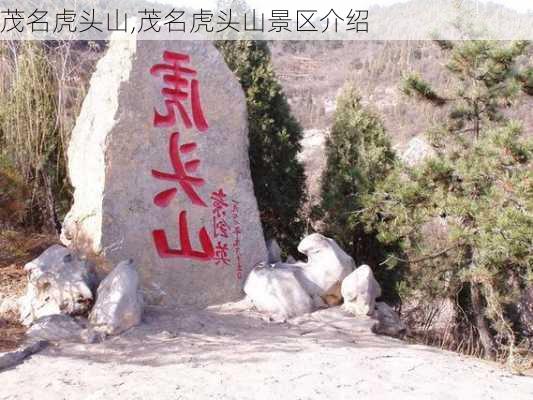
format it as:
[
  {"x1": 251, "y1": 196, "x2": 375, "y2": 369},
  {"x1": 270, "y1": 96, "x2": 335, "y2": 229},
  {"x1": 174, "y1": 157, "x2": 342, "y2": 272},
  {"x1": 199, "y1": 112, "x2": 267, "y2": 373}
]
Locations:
[{"x1": 0, "y1": 305, "x2": 533, "y2": 400}]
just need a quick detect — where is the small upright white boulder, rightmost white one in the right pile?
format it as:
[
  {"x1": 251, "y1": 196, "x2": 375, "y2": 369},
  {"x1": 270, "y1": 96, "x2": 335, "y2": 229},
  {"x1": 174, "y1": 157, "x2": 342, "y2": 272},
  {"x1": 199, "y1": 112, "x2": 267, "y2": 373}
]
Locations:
[{"x1": 341, "y1": 265, "x2": 381, "y2": 315}]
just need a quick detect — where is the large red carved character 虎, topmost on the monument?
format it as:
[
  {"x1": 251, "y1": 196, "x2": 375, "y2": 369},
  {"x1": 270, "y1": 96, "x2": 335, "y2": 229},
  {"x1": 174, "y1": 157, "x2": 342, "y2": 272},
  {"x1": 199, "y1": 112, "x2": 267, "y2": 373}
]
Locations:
[{"x1": 150, "y1": 51, "x2": 209, "y2": 132}]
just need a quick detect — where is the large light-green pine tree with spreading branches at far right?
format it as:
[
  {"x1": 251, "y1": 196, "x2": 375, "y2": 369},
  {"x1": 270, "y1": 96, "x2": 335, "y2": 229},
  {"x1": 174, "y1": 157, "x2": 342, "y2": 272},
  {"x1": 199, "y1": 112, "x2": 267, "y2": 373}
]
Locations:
[{"x1": 363, "y1": 41, "x2": 533, "y2": 361}]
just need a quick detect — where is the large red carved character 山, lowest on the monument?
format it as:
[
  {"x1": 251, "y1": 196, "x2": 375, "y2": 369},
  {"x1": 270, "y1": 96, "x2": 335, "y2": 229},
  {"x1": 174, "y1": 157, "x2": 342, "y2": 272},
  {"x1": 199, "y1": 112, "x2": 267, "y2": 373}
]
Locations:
[{"x1": 152, "y1": 211, "x2": 215, "y2": 261}]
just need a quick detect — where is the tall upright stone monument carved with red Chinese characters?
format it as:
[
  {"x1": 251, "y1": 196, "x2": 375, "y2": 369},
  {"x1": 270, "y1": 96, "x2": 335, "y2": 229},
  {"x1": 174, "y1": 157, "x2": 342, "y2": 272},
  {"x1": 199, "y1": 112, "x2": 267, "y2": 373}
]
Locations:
[{"x1": 62, "y1": 39, "x2": 267, "y2": 306}]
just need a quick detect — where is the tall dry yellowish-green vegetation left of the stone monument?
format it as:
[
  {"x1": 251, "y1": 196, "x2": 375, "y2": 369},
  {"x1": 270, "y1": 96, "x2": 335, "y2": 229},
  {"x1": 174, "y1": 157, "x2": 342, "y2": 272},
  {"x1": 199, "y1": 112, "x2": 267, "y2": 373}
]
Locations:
[{"x1": 0, "y1": 41, "x2": 103, "y2": 232}]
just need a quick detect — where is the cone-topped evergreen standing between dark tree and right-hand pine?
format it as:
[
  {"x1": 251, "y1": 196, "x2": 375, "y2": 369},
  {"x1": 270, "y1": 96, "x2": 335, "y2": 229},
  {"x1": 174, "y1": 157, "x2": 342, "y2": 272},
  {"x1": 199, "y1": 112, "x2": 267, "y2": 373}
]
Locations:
[{"x1": 317, "y1": 83, "x2": 394, "y2": 290}]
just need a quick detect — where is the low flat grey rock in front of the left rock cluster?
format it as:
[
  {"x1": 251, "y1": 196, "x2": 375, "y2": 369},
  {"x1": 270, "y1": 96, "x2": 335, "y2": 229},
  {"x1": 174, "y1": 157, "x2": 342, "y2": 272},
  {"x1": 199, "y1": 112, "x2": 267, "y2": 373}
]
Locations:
[{"x1": 26, "y1": 314, "x2": 83, "y2": 342}]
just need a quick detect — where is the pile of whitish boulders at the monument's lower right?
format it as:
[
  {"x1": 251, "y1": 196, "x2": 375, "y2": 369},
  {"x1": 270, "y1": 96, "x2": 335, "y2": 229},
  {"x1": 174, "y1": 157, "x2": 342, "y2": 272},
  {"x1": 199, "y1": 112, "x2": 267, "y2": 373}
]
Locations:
[{"x1": 244, "y1": 233, "x2": 406, "y2": 336}]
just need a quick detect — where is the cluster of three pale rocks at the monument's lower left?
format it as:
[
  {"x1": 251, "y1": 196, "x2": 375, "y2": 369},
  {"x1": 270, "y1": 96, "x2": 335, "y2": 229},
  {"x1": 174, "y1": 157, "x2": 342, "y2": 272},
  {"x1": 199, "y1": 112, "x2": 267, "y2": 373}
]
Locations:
[{"x1": 20, "y1": 245, "x2": 143, "y2": 342}]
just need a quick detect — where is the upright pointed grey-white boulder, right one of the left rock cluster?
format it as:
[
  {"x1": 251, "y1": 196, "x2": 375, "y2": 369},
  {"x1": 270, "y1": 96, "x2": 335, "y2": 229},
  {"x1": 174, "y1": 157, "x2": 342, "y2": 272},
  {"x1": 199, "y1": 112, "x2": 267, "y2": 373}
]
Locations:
[{"x1": 89, "y1": 260, "x2": 143, "y2": 335}]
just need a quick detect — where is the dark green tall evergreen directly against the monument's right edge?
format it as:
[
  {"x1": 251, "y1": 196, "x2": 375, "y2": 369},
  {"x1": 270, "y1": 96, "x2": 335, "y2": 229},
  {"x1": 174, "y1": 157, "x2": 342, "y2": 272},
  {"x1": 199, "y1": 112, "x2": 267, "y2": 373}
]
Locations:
[{"x1": 217, "y1": 41, "x2": 305, "y2": 251}]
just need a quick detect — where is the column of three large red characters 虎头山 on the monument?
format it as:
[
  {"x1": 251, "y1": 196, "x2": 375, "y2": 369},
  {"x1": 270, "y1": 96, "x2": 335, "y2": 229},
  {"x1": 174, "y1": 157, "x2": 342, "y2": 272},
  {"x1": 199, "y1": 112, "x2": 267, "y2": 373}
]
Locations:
[{"x1": 150, "y1": 51, "x2": 216, "y2": 264}]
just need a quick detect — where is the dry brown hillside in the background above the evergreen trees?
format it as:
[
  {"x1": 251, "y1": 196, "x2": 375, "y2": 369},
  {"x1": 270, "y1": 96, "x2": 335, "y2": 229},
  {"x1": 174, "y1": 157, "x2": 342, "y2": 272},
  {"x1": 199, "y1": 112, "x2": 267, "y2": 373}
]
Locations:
[{"x1": 272, "y1": 41, "x2": 533, "y2": 144}]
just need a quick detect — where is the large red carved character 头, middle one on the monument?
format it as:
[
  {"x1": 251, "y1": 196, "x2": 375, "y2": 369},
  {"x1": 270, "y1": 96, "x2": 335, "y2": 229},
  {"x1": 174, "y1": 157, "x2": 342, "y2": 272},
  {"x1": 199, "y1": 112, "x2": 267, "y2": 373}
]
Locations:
[{"x1": 152, "y1": 132, "x2": 207, "y2": 207}]
